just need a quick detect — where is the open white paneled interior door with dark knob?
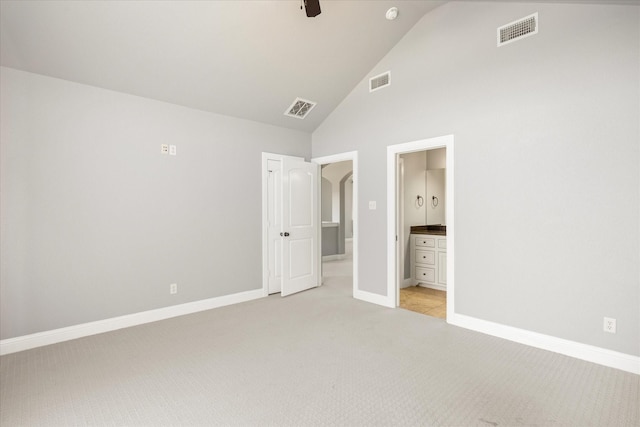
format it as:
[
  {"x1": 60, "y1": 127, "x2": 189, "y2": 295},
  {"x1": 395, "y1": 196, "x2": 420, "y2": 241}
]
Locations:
[{"x1": 281, "y1": 157, "x2": 320, "y2": 296}]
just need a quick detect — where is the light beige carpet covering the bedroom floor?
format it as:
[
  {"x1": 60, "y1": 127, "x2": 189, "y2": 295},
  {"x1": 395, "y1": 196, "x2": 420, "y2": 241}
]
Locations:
[{"x1": 0, "y1": 276, "x2": 640, "y2": 427}]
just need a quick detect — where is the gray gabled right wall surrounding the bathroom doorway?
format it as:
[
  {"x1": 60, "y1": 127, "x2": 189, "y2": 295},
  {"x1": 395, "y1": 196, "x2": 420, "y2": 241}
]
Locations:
[{"x1": 312, "y1": 2, "x2": 640, "y2": 356}]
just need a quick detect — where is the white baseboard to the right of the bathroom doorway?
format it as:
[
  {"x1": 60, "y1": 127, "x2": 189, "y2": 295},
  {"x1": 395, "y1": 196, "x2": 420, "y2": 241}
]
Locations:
[{"x1": 447, "y1": 313, "x2": 640, "y2": 375}]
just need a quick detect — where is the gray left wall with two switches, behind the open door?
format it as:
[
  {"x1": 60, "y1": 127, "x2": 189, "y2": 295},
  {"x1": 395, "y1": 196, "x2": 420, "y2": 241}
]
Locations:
[{"x1": 0, "y1": 68, "x2": 311, "y2": 339}]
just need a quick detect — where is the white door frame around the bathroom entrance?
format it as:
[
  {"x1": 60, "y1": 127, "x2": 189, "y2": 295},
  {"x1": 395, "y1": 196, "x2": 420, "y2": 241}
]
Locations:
[{"x1": 385, "y1": 135, "x2": 455, "y2": 323}]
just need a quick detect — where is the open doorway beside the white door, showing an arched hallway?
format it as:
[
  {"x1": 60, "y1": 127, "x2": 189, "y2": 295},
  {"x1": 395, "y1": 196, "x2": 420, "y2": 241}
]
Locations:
[{"x1": 311, "y1": 151, "x2": 358, "y2": 296}]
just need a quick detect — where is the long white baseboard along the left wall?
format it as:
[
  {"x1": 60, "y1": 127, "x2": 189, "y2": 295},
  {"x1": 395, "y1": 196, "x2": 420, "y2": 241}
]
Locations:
[{"x1": 0, "y1": 288, "x2": 264, "y2": 355}]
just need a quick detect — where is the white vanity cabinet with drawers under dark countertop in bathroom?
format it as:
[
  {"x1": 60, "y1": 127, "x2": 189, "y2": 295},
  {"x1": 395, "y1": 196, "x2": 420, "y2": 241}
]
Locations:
[{"x1": 409, "y1": 234, "x2": 447, "y2": 290}]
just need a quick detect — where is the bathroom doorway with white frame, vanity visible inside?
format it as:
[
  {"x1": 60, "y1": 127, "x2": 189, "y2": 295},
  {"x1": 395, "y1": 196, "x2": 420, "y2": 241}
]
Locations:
[{"x1": 387, "y1": 135, "x2": 454, "y2": 318}]
